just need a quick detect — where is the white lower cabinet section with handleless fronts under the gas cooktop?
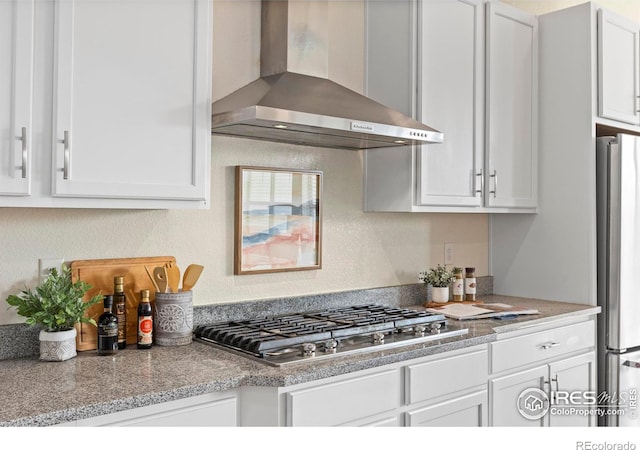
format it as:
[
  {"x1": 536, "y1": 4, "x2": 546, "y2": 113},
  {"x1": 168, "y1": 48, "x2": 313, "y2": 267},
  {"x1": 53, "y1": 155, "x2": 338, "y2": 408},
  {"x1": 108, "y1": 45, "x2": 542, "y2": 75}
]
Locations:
[{"x1": 239, "y1": 345, "x2": 489, "y2": 427}]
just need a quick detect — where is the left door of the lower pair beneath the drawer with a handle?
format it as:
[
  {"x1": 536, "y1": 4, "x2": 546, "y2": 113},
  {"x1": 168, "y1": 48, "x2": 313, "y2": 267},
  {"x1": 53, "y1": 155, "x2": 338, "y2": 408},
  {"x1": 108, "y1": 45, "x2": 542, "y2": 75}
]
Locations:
[{"x1": 489, "y1": 365, "x2": 549, "y2": 427}]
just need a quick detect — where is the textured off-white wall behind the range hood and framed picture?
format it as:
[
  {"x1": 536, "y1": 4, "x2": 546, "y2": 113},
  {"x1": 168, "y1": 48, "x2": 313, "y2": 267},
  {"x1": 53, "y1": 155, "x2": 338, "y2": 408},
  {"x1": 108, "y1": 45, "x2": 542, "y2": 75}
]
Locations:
[{"x1": 0, "y1": 0, "x2": 488, "y2": 324}]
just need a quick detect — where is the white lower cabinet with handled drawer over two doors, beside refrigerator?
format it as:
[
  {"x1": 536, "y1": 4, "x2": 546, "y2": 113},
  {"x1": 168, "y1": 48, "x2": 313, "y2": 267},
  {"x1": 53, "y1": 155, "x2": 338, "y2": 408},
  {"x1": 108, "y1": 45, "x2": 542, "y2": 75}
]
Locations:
[{"x1": 489, "y1": 320, "x2": 597, "y2": 427}]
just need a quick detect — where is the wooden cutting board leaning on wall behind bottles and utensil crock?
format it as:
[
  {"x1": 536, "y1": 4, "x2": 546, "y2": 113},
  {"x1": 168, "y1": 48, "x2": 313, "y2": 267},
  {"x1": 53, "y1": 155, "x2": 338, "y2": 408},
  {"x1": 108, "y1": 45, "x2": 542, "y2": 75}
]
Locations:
[{"x1": 69, "y1": 256, "x2": 176, "y2": 351}]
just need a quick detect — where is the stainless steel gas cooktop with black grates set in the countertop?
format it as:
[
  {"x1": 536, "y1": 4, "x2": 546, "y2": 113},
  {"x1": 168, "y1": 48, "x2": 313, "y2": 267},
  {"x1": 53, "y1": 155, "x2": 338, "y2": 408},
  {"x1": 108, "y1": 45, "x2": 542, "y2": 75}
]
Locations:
[{"x1": 194, "y1": 305, "x2": 468, "y2": 366}]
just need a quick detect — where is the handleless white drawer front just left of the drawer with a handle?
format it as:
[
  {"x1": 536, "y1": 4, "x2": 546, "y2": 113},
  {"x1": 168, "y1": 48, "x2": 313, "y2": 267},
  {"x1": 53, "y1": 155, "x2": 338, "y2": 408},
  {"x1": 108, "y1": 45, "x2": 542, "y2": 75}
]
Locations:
[{"x1": 407, "y1": 349, "x2": 489, "y2": 404}]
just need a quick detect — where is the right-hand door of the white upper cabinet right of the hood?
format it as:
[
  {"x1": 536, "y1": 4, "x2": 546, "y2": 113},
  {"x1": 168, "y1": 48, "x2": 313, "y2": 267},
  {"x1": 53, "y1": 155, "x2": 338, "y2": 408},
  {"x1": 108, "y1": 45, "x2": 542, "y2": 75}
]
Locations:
[{"x1": 485, "y1": 2, "x2": 538, "y2": 208}]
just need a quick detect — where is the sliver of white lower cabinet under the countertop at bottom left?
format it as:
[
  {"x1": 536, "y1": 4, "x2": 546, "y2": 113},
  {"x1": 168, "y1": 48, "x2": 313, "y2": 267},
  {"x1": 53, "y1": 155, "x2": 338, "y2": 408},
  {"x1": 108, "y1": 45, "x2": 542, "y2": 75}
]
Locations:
[{"x1": 75, "y1": 392, "x2": 237, "y2": 427}]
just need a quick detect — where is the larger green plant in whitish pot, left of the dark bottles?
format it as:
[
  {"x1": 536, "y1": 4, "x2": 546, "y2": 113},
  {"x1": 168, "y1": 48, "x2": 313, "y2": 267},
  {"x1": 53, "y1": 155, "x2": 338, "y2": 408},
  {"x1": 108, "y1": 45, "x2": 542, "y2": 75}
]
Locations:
[{"x1": 6, "y1": 264, "x2": 102, "y2": 361}]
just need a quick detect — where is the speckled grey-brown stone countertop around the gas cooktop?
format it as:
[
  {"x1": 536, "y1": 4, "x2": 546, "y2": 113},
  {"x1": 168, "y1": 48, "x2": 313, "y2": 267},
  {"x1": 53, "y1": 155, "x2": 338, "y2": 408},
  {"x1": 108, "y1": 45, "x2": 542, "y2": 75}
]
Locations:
[{"x1": 0, "y1": 295, "x2": 600, "y2": 426}]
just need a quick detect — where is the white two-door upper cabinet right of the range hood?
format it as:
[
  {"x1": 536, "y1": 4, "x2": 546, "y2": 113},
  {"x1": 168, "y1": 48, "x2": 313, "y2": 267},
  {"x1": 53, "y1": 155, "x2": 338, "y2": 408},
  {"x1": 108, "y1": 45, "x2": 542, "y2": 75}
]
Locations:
[{"x1": 364, "y1": 0, "x2": 538, "y2": 212}]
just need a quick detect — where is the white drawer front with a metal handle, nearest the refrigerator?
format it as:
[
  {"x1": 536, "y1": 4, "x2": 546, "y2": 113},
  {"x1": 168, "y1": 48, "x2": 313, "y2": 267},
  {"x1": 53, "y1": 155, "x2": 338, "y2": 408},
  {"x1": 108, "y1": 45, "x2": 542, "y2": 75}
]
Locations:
[{"x1": 491, "y1": 322, "x2": 595, "y2": 373}]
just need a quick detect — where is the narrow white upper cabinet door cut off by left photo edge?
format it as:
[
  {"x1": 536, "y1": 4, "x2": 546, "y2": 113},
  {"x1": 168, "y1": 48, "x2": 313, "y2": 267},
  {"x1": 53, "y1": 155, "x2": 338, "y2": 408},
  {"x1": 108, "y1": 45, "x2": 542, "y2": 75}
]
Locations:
[{"x1": 0, "y1": 0, "x2": 34, "y2": 195}]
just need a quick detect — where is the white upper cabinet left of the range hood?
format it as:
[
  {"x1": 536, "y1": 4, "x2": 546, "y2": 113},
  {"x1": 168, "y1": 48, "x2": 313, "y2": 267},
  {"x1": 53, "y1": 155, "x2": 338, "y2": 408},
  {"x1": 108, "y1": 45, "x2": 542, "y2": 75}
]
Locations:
[{"x1": 0, "y1": 0, "x2": 212, "y2": 209}]
